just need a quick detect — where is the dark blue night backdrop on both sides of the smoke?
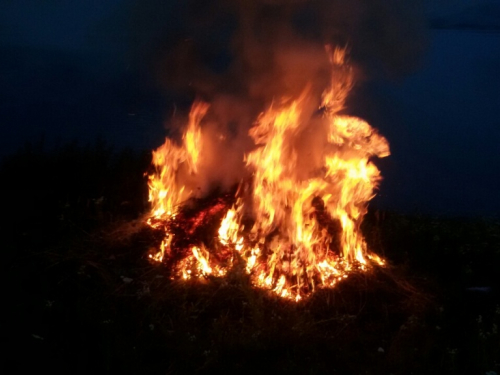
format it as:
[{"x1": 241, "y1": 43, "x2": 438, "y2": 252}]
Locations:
[{"x1": 0, "y1": 0, "x2": 500, "y2": 215}]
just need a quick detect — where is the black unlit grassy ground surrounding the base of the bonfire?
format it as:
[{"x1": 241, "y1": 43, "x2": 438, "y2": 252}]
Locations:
[{"x1": 0, "y1": 142, "x2": 500, "y2": 374}]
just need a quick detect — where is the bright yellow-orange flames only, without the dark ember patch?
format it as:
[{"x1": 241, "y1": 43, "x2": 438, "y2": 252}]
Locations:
[{"x1": 148, "y1": 49, "x2": 389, "y2": 300}]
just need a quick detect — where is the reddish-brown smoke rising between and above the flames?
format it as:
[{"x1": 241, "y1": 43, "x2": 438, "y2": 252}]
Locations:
[{"x1": 115, "y1": 0, "x2": 426, "y2": 194}]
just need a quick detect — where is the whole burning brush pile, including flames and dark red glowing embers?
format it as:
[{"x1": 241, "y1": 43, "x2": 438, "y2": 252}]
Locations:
[{"x1": 147, "y1": 46, "x2": 389, "y2": 301}]
